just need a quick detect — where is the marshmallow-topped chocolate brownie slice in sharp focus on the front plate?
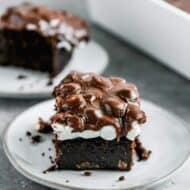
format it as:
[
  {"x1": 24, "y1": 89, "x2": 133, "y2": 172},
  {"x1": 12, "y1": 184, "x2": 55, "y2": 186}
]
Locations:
[{"x1": 38, "y1": 72, "x2": 150, "y2": 170}]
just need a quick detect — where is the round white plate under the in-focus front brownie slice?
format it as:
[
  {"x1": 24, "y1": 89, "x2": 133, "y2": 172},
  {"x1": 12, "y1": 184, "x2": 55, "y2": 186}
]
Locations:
[{"x1": 3, "y1": 100, "x2": 190, "y2": 190}]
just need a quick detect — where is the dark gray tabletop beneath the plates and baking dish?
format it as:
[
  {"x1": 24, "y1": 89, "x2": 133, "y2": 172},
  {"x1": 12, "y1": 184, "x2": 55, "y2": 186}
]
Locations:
[{"x1": 0, "y1": 25, "x2": 190, "y2": 190}]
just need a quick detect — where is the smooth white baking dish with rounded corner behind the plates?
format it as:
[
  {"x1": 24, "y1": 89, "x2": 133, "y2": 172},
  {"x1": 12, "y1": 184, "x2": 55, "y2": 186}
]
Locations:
[{"x1": 88, "y1": 0, "x2": 190, "y2": 79}]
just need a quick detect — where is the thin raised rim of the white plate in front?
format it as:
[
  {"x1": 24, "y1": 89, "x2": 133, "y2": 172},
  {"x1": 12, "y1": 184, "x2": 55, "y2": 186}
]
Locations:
[{"x1": 1, "y1": 99, "x2": 190, "y2": 190}]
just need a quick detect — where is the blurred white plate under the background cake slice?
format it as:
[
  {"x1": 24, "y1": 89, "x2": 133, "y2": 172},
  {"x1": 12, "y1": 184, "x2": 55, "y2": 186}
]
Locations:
[{"x1": 0, "y1": 41, "x2": 108, "y2": 98}]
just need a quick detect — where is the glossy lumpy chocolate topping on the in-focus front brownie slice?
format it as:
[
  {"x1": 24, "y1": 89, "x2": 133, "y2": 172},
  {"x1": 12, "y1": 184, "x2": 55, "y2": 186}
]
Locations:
[{"x1": 51, "y1": 72, "x2": 146, "y2": 138}]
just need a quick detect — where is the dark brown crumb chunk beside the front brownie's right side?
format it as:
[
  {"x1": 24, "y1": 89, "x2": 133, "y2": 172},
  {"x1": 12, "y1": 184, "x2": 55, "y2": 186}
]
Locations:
[{"x1": 135, "y1": 139, "x2": 152, "y2": 161}]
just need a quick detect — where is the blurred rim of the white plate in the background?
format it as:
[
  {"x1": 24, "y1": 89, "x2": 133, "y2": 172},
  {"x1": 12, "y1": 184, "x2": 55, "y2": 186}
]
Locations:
[{"x1": 0, "y1": 39, "x2": 110, "y2": 99}]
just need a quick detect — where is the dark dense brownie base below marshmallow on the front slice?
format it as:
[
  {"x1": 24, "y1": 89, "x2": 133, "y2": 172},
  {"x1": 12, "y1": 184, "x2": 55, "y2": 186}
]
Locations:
[{"x1": 55, "y1": 138, "x2": 135, "y2": 170}]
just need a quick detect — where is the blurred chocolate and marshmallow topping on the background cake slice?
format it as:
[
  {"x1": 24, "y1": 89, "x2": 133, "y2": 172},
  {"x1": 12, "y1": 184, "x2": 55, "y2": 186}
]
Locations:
[{"x1": 0, "y1": 3, "x2": 89, "y2": 48}]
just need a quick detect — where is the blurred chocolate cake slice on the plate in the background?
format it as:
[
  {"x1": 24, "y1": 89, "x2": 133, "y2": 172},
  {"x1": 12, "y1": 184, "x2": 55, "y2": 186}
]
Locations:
[{"x1": 0, "y1": 3, "x2": 89, "y2": 76}]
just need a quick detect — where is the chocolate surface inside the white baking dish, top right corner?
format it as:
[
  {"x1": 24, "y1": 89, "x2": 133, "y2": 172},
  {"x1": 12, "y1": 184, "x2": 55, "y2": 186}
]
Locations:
[{"x1": 166, "y1": 0, "x2": 190, "y2": 13}]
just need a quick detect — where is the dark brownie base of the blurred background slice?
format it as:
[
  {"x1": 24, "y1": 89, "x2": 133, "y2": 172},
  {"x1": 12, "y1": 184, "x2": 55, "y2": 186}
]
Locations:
[{"x1": 0, "y1": 29, "x2": 72, "y2": 76}]
